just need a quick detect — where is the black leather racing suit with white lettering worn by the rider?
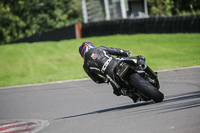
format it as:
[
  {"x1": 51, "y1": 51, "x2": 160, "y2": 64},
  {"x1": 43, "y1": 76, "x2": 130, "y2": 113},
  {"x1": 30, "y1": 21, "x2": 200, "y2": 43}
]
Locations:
[{"x1": 83, "y1": 46, "x2": 133, "y2": 95}]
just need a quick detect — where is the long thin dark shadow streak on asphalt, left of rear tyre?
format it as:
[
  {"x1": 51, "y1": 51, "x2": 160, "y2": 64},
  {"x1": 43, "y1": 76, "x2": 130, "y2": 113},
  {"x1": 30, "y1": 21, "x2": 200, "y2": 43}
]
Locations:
[{"x1": 55, "y1": 102, "x2": 152, "y2": 120}]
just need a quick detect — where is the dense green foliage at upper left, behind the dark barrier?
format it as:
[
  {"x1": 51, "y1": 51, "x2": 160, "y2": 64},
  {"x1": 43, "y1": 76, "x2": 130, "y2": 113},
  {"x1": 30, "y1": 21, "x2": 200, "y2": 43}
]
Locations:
[{"x1": 0, "y1": 0, "x2": 81, "y2": 43}]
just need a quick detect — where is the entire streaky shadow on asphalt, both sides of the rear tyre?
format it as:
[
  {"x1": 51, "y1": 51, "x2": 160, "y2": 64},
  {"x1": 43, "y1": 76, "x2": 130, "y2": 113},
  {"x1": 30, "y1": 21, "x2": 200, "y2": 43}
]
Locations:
[{"x1": 55, "y1": 91, "x2": 200, "y2": 120}]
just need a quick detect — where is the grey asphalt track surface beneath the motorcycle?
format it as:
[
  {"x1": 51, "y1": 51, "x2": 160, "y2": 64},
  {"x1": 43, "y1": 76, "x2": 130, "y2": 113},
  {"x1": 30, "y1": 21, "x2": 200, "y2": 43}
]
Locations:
[{"x1": 0, "y1": 66, "x2": 200, "y2": 133}]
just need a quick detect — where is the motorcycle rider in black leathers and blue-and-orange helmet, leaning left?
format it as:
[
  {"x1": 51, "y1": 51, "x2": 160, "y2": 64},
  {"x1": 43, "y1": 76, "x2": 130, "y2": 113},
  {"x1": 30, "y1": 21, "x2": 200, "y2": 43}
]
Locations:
[{"x1": 79, "y1": 42, "x2": 145, "y2": 102}]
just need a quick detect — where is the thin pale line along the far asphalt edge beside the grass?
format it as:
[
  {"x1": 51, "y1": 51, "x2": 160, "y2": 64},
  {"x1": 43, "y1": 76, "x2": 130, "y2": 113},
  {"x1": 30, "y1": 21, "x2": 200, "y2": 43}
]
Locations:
[{"x1": 0, "y1": 66, "x2": 200, "y2": 90}]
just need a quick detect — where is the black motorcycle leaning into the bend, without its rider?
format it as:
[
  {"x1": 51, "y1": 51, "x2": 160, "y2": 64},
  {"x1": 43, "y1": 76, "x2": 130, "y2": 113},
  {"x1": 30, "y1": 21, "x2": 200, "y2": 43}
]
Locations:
[{"x1": 115, "y1": 57, "x2": 164, "y2": 103}]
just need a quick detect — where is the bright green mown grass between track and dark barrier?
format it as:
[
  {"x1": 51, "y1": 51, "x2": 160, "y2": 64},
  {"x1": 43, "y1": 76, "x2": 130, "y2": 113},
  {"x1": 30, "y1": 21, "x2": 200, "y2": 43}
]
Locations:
[{"x1": 0, "y1": 34, "x2": 200, "y2": 87}]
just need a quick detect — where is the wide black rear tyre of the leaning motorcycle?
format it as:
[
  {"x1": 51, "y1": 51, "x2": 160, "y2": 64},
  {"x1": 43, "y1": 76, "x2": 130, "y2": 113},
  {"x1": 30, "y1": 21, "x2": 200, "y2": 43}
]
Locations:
[{"x1": 130, "y1": 73, "x2": 164, "y2": 103}]
